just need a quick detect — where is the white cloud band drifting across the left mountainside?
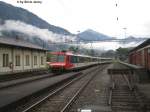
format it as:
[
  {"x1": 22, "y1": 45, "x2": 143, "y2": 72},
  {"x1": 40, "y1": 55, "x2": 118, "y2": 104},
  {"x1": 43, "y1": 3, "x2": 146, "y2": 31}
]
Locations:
[{"x1": 0, "y1": 20, "x2": 75, "y2": 42}]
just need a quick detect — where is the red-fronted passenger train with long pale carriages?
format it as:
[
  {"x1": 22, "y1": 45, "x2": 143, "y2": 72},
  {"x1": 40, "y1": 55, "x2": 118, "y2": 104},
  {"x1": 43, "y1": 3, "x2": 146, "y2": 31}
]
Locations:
[{"x1": 47, "y1": 52, "x2": 112, "y2": 71}]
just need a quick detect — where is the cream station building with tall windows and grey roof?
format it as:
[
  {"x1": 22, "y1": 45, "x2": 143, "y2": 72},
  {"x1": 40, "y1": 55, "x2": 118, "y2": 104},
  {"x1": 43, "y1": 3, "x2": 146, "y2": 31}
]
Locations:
[{"x1": 0, "y1": 37, "x2": 47, "y2": 75}]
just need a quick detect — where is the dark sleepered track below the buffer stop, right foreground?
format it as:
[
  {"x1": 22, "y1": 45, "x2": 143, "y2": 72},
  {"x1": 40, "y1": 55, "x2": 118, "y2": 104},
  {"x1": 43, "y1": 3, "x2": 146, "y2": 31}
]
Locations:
[{"x1": 109, "y1": 75, "x2": 150, "y2": 112}]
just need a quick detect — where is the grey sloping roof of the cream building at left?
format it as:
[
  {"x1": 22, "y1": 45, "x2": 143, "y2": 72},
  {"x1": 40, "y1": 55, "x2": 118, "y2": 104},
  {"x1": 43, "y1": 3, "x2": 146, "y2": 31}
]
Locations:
[{"x1": 0, "y1": 37, "x2": 46, "y2": 51}]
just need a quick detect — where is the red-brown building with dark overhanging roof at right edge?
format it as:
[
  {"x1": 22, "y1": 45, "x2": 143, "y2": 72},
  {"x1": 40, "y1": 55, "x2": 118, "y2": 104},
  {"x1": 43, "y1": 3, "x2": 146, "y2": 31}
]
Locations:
[{"x1": 129, "y1": 39, "x2": 150, "y2": 71}]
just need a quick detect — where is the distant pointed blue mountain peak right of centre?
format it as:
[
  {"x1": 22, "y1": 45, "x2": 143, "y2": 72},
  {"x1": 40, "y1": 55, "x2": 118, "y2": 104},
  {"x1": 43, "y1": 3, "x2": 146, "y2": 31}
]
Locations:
[{"x1": 77, "y1": 29, "x2": 112, "y2": 41}]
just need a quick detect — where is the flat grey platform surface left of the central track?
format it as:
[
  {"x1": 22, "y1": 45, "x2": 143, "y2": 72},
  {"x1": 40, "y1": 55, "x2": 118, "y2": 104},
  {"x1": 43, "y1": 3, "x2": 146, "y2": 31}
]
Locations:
[{"x1": 0, "y1": 73, "x2": 79, "y2": 108}]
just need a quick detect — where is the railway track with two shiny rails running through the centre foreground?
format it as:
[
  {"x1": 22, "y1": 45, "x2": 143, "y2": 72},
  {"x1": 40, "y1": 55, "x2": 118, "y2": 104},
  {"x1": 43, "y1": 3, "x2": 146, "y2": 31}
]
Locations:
[{"x1": 19, "y1": 67, "x2": 104, "y2": 112}]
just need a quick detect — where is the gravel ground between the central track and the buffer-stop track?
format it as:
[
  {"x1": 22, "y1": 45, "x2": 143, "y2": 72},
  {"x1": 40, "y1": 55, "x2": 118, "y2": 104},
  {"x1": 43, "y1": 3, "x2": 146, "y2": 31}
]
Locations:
[{"x1": 69, "y1": 65, "x2": 113, "y2": 112}]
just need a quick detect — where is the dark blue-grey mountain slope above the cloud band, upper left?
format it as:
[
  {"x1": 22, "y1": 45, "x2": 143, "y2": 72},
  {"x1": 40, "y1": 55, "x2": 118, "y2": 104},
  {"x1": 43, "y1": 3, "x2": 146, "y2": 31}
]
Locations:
[{"x1": 0, "y1": 1, "x2": 70, "y2": 35}]
